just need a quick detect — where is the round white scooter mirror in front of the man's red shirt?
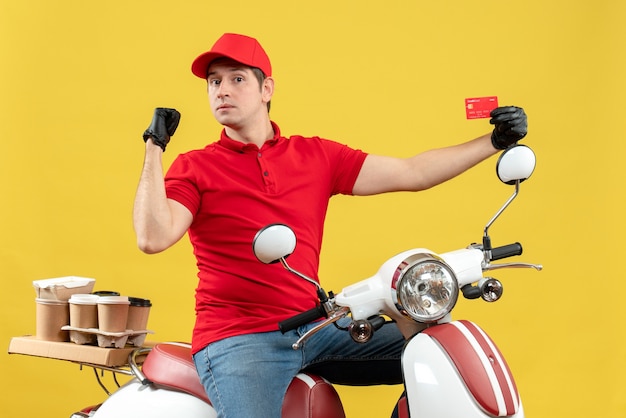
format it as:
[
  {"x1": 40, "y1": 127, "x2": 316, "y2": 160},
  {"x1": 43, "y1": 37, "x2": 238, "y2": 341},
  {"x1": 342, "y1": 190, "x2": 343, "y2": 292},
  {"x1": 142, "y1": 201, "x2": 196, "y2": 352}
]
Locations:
[{"x1": 252, "y1": 224, "x2": 296, "y2": 264}]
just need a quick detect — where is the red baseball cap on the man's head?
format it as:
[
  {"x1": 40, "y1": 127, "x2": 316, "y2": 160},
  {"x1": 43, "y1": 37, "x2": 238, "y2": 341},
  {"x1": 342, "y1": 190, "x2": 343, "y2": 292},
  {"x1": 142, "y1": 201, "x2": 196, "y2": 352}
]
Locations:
[{"x1": 191, "y1": 33, "x2": 272, "y2": 79}]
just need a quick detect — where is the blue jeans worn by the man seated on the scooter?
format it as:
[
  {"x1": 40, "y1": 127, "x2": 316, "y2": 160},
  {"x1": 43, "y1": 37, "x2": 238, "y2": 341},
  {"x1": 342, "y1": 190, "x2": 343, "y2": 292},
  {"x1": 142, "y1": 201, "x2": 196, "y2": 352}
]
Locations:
[{"x1": 194, "y1": 323, "x2": 404, "y2": 418}]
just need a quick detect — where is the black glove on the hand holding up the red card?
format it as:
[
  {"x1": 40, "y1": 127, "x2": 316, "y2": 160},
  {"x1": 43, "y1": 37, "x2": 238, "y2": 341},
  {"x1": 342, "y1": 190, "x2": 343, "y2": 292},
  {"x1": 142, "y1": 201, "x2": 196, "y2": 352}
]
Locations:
[{"x1": 489, "y1": 106, "x2": 528, "y2": 149}]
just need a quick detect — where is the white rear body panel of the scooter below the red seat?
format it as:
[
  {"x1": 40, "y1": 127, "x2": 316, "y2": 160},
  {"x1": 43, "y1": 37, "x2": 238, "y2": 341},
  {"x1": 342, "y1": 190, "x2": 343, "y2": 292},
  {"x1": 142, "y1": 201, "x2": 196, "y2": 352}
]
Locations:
[{"x1": 93, "y1": 379, "x2": 217, "y2": 418}]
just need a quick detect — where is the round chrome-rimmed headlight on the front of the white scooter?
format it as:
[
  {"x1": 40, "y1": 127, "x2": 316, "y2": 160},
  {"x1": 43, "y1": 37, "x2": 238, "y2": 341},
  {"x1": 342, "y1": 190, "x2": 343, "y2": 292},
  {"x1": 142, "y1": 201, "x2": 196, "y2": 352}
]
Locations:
[{"x1": 391, "y1": 253, "x2": 459, "y2": 323}]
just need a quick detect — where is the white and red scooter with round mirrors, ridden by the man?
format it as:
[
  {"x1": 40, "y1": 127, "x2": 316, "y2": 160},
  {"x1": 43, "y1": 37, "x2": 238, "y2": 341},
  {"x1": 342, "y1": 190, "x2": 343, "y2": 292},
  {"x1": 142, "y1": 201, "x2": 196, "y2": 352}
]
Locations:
[{"x1": 72, "y1": 145, "x2": 542, "y2": 418}]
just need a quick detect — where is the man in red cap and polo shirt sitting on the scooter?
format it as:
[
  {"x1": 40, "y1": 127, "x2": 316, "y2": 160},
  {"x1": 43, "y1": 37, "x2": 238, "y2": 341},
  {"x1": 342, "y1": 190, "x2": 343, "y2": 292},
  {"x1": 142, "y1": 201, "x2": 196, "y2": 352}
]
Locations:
[{"x1": 133, "y1": 34, "x2": 527, "y2": 418}]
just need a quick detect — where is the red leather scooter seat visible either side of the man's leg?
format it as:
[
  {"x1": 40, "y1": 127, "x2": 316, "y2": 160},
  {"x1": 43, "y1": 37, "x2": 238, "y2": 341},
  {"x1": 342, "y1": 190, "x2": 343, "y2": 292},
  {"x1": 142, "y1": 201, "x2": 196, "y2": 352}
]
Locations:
[{"x1": 142, "y1": 343, "x2": 346, "y2": 418}]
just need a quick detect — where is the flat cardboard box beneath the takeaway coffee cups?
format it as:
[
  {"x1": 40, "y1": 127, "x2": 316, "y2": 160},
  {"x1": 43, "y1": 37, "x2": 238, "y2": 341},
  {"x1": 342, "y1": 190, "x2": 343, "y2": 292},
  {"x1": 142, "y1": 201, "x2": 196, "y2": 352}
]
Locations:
[{"x1": 9, "y1": 335, "x2": 144, "y2": 367}]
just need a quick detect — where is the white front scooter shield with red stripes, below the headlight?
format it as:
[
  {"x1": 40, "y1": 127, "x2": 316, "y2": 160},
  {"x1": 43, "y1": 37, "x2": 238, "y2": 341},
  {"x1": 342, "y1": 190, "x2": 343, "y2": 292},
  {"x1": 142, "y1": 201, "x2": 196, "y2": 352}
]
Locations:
[{"x1": 402, "y1": 321, "x2": 524, "y2": 418}]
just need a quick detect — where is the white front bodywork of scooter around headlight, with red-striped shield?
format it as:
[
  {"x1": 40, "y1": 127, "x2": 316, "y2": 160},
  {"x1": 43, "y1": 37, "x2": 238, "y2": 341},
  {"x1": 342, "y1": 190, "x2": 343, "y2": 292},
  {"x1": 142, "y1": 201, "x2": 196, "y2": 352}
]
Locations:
[{"x1": 335, "y1": 248, "x2": 524, "y2": 418}]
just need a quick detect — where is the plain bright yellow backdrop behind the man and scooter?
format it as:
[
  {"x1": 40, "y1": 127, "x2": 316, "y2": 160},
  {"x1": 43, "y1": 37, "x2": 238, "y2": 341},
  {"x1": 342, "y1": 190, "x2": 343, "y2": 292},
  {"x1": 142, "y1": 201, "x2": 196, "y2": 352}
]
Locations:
[{"x1": 0, "y1": 0, "x2": 626, "y2": 417}]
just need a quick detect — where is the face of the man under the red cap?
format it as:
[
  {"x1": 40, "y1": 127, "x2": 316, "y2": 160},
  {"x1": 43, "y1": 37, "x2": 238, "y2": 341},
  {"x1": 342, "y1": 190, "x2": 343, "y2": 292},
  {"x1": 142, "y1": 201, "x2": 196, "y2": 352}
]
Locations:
[{"x1": 207, "y1": 59, "x2": 272, "y2": 129}]
